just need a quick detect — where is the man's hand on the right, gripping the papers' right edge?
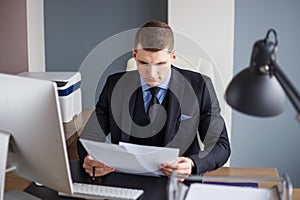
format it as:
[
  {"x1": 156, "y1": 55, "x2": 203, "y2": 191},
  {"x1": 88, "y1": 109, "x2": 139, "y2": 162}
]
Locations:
[{"x1": 158, "y1": 157, "x2": 194, "y2": 181}]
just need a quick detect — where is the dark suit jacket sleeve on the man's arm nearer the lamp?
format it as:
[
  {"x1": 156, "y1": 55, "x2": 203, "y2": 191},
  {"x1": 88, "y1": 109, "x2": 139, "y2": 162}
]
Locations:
[{"x1": 188, "y1": 77, "x2": 231, "y2": 174}]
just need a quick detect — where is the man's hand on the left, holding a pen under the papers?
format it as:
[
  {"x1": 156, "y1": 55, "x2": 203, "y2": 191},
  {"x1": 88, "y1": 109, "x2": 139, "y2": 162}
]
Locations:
[{"x1": 83, "y1": 155, "x2": 115, "y2": 176}]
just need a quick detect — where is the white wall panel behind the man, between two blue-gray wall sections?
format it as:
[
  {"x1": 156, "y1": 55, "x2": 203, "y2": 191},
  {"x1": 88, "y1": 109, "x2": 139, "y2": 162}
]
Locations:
[{"x1": 168, "y1": 0, "x2": 234, "y2": 145}]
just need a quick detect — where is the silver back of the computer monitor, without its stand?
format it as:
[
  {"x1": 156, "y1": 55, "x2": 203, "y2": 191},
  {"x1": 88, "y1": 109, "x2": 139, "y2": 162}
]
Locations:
[{"x1": 0, "y1": 73, "x2": 72, "y2": 197}]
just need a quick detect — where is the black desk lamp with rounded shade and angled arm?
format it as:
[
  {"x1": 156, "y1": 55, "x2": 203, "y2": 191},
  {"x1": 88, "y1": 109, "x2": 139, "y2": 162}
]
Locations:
[{"x1": 225, "y1": 29, "x2": 300, "y2": 122}]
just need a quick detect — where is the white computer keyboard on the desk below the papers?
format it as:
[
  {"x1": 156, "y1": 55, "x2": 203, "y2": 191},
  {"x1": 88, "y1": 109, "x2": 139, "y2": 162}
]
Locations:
[{"x1": 58, "y1": 183, "x2": 144, "y2": 200}]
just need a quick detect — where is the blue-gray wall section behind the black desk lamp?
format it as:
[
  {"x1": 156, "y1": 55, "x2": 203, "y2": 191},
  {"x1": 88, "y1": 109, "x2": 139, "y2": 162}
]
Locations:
[{"x1": 231, "y1": 0, "x2": 300, "y2": 187}]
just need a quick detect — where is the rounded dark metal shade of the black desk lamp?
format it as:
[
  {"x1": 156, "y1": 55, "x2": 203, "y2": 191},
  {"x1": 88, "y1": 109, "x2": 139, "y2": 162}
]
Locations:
[{"x1": 225, "y1": 67, "x2": 285, "y2": 117}]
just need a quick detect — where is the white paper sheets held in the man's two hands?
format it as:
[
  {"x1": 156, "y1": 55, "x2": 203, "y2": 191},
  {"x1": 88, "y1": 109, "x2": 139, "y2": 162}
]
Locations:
[{"x1": 80, "y1": 139, "x2": 179, "y2": 176}]
